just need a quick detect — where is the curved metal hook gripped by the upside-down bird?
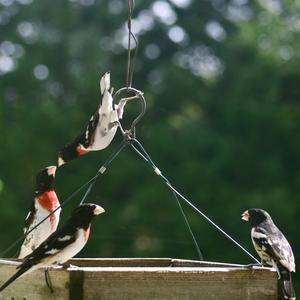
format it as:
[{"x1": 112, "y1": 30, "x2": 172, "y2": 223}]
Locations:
[{"x1": 114, "y1": 87, "x2": 147, "y2": 140}]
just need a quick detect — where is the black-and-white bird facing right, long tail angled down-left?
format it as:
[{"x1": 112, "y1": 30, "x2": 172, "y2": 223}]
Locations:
[{"x1": 0, "y1": 204, "x2": 104, "y2": 292}]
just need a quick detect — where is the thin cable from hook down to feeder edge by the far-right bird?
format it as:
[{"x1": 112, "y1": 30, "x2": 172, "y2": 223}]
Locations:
[{"x1": 131, "y1": 139, "x2": 260, "y2": 264}]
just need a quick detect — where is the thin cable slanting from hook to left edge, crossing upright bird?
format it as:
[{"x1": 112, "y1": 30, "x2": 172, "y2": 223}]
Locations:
[{"x1": 0, "y1": 141, "x2": 127, "y2": 257}]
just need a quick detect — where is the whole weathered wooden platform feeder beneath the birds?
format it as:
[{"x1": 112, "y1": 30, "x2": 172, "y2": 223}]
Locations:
[{"x1": 0, "y1": 258, "x2": 278, "y2": 300}]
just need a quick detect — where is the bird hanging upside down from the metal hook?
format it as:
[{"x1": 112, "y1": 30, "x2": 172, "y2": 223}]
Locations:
[{"x1": 58, "y1": 73, "x2": 126, "y2": 166}]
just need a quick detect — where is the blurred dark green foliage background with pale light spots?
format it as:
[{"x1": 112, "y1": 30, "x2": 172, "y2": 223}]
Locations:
[{"x1": 0, "y1": 0, "x2": 300, "y2": 292}]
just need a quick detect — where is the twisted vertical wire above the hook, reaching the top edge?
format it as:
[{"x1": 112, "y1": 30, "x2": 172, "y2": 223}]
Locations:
[{"x1": 126, "y1": 0, "x2": 138, "y2": 88}]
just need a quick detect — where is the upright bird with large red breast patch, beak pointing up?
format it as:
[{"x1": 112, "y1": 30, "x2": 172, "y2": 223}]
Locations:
[{"x1": 18, "y1": 166, "x2": 61, "y2": 258}]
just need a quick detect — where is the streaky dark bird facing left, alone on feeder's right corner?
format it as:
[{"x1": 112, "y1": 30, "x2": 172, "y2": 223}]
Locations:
[{"x1": 242, "y1": 208, "x2": 296, "y2": 300}]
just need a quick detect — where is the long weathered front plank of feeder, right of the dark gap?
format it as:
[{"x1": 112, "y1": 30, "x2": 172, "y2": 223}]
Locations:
[{"x1": 84, "y1": 268, "x2": 277, "y2": 300}]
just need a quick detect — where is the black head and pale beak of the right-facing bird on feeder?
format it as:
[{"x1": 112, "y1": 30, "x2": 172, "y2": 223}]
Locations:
[{"x1": 71, "y1": 203, "x2": 105, "y2": 229}]
